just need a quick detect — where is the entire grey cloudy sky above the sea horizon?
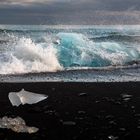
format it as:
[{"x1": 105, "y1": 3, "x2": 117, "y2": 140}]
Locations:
[{"x1": 0, "y1": 0, "x2": 140, "y2": 25}]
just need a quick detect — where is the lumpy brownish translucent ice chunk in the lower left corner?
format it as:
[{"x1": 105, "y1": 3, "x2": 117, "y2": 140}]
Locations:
[{"x1": 0, "y1": 116, "x2": 39, "y2": 134}]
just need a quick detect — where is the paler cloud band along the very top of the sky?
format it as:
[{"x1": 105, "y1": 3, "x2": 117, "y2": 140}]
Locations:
[{"x1": 0, "y1": 0, "x2": 140, "y2": 11}]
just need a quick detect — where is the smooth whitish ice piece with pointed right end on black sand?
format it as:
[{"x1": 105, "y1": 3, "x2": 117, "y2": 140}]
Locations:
[{"x1": 8, "y1": 89, "x2": 48, "y2": 106}]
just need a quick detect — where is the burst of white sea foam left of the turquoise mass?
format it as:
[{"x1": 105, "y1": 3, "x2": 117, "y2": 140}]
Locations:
[{"x1": 0, "y1": 37, "x2": 62, "y2": 74}]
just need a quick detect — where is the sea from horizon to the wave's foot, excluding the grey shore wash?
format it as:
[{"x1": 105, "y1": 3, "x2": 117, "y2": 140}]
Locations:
[{"x1": 0, "y1": 25, "x2": 140, "y2": 74}]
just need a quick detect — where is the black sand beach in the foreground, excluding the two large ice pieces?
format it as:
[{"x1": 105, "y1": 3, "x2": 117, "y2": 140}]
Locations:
[{"x1": 0, "y1": 82, "x2": 140, "y2": 140}]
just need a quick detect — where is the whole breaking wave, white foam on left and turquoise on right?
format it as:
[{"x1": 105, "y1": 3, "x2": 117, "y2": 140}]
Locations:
[{"x1": 0, "y1": 32, "x2": 140, "y2": 74}]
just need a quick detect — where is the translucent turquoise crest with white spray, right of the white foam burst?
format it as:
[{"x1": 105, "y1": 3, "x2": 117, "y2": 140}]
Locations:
[{"x1": 57, "y1": 33, "x2": 140, "y2": 67}]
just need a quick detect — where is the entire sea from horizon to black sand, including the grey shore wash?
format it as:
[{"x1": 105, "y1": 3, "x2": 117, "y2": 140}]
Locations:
[{"x1": 0, "y1": 25, "x2": 140, "y2": 82}]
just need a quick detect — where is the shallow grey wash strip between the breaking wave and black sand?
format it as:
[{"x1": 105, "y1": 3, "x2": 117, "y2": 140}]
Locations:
[{"x1": 0, "y1": 67, "x2": 140, "y2": 83}]
